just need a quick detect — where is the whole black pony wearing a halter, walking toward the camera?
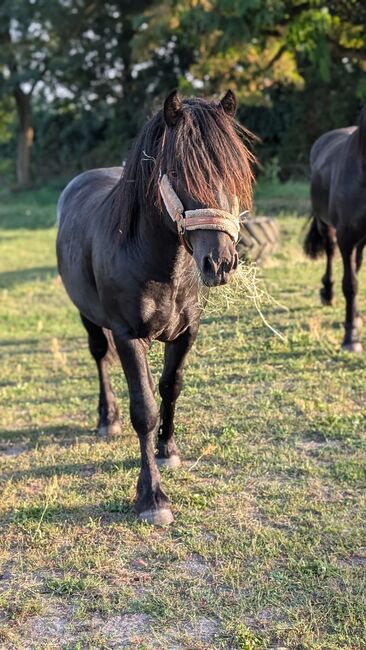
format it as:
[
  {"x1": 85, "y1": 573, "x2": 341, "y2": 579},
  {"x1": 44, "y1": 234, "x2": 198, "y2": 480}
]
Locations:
[{"x1": 57, "y1": 91, "x2": 253, "y2": 525}]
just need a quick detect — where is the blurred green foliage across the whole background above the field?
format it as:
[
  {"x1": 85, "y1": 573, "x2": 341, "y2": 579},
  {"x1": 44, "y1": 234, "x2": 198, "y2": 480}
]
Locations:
[{"x1": 0, "y1": 0, "x2": 366, "y2": 178}]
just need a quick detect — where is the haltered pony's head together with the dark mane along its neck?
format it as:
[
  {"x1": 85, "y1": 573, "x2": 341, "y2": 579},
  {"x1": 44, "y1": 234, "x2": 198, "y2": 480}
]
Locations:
[{"x1": 112, "y1": 90, "x2": 255, "y2": 286}]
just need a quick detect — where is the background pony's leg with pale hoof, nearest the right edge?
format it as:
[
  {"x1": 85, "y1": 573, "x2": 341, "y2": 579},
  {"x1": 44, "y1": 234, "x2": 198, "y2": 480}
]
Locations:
[{"x1": 340, "y1": 246, "x2": 362, "y2": 352}]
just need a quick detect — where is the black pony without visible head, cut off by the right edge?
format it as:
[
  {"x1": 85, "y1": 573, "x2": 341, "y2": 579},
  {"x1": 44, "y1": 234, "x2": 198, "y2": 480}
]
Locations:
[{"x1": 304, "y1": 103, "x2": 366, "y2": 352}]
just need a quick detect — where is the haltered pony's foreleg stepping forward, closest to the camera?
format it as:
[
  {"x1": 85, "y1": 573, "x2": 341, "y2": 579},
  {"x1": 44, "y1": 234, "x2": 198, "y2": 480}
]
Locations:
[{"x1": 113, "y1": 331, "x2": 173, "y2": 526}]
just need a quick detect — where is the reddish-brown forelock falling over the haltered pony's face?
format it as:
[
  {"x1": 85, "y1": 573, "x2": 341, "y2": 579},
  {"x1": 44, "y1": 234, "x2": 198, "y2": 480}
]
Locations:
[{"x1": 151, "y1": 99, "x2": 255, "y2": 209}]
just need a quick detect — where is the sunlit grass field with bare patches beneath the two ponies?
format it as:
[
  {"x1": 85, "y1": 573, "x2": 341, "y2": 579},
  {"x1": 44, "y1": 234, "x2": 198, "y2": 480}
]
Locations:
[{"x1": 0, "y1": 178, "x2": 366, "y2": 650}]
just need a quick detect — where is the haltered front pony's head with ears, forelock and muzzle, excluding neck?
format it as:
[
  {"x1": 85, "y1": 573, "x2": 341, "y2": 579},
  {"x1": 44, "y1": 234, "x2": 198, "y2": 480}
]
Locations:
[{"x1": 155, "y1": 90, "x2": 254, "y2": 286}]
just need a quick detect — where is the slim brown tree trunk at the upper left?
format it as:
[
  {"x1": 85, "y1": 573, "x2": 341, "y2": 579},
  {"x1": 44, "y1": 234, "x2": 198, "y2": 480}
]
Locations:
[{"x1": 14, "y1": 86, "x2": 33, "y2": 189}]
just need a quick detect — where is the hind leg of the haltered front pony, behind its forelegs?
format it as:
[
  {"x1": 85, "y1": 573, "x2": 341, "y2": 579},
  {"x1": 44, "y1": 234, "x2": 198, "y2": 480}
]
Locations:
[{"x1": 80, "y1": 314, "x2": 121, "y2": 437}]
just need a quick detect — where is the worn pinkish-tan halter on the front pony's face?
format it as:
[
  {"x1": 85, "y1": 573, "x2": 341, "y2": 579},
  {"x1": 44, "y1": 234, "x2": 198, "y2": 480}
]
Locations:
[{"x1": 159, "y1": 174, "x2": 240, "y2": 255}]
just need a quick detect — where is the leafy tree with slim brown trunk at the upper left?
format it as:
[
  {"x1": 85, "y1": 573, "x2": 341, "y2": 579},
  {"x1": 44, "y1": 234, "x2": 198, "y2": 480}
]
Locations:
[{"x1": 0, "y1": 0, "x2": 156, "y2": 187}]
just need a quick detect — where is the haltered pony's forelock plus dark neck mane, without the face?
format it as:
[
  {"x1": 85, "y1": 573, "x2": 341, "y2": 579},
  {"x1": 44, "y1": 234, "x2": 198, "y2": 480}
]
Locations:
[{"x1": 108, "y1": 99, "x2": 255, "y2": 241}]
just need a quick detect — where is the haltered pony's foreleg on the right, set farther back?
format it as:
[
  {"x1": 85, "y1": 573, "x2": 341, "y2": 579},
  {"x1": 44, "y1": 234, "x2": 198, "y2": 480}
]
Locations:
[{"x1": 157, "y1": 325, "x2": 198, "y2": 469}]
